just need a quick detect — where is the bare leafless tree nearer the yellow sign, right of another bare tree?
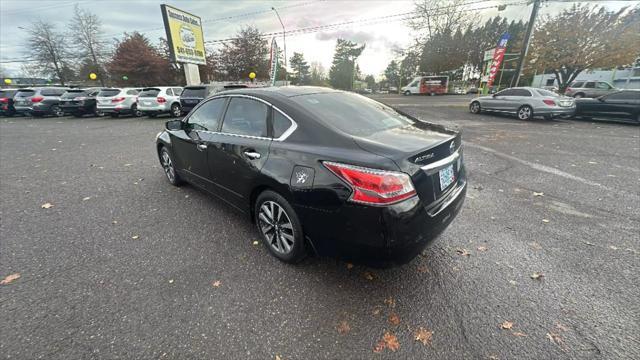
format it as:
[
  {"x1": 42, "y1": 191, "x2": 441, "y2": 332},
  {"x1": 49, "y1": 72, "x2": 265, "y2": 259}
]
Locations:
[{"x1": 69, "y1": 5, "x2": 106, "y2": 86}]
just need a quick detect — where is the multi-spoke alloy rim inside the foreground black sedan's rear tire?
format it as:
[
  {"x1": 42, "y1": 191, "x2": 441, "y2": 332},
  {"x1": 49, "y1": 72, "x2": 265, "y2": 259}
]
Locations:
[{"x1": 258, "y1": 201, "x2": 295, "y2": 254}]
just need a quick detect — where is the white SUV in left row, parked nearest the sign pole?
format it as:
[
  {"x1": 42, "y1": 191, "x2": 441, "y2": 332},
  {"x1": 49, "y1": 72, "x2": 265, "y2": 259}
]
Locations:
[{"x1": 138, "y1": 86, "x2": 182, "y2": 117}]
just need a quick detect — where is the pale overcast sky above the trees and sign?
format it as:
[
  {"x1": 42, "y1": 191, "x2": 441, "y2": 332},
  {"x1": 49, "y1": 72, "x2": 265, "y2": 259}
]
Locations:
[{"x1": 0, "y1": 0, "x2": 640, "y2": 76}]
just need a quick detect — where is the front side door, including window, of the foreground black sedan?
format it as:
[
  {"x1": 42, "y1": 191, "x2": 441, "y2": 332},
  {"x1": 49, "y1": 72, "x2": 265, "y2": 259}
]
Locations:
[{"x1": 170, "y1": 98, "x2": 226, "y2": 190}]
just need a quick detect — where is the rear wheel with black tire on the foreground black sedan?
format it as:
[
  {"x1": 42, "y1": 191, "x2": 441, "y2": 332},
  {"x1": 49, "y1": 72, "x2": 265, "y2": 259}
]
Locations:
[{"x1": 254, "y1": 190, "x2": 307, "y2": 264}]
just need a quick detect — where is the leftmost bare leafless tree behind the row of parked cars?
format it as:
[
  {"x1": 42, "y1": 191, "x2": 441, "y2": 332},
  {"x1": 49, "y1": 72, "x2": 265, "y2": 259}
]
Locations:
[{"x1": 27, "y1": 20, "x2": 69, "y2": 85}]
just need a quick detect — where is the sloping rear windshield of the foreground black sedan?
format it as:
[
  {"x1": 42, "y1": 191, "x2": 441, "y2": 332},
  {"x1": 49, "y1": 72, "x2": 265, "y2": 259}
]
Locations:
[{"x1": 290, "y1": 92, "x2": 414, "y2": 136}]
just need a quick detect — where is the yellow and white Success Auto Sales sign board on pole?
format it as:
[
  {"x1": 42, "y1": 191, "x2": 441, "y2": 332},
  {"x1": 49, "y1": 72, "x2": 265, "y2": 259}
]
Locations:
[{"x1": 160, "y1": 4, "x2": 207, "y2": 65}]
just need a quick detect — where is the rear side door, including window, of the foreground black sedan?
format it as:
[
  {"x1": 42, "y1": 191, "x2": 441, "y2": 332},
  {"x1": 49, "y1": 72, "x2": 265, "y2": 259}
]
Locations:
[{"x1": 208, "y1": 96, "x2": 271, "y2": 210}]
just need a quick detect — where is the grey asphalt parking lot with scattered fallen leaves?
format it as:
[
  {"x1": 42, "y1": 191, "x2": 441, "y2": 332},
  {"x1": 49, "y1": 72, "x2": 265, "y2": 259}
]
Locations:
[{"x1": 0, "y1": 95, "x2": 640, "y2": 360}]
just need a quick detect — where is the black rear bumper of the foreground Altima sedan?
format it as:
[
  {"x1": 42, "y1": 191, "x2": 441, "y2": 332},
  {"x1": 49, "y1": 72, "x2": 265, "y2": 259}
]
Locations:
[{"x1": 296, "y1": 170, "x2": 467, "y2": 267}]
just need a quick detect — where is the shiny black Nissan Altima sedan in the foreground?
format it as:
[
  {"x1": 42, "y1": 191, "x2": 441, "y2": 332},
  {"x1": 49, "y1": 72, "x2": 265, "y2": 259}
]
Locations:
[{"x1": 157, "y1": 87, "x2": 466, "y2": 266}]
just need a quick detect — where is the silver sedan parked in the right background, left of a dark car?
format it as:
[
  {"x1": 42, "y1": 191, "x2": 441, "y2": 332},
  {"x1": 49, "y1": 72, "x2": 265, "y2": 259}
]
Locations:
[{"x1": 469, "y1": 87, "x2": 576, "y2": 120}]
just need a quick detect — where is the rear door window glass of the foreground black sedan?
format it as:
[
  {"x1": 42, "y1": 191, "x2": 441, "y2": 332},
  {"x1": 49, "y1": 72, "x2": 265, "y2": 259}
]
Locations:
[{"x1": 222, "y1": 98, "x2": 269, "y2": 137}]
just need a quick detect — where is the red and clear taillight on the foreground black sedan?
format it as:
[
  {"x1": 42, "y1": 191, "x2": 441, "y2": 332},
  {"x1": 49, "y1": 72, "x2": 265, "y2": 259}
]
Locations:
[{"x1": 322, "y1": 161, "x2": 416, "y2": 205}]
